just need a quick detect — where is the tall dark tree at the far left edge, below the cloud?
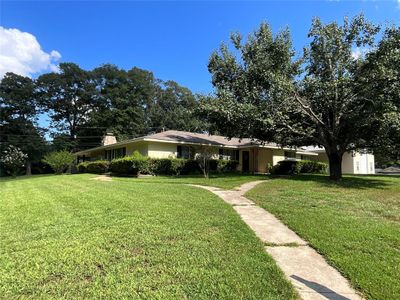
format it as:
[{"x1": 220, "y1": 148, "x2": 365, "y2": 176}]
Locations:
[{"x1": 0, "y1": 73, "x2": 47, "y2": 175}]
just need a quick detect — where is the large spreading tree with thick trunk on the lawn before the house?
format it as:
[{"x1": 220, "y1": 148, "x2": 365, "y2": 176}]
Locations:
[{"x1": 203, "y1": 15, "x2": 382, "y2": 180}]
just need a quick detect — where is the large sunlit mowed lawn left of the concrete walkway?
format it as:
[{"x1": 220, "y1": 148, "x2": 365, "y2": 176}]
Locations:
[{"x1": 0, "y1": 175, "x2": 297, "y2": 299}]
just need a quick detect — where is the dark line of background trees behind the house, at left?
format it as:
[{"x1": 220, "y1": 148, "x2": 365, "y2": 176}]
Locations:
[{"x1": 0, "y1": 63, "x2": 205, "y2": 168}]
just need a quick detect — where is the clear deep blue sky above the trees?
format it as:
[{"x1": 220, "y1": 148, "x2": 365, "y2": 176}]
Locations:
[{"x1": 0, "y1": 0, "x2": 400, "y2": 93}]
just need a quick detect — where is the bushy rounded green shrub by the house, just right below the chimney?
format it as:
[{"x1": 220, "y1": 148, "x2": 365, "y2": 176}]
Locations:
[{"x1": 109, "y1": 151, "x2": 150, "y2": 176}]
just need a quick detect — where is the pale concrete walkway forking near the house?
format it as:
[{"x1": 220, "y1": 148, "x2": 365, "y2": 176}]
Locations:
[{"x1": 192, "y1": 181, "x2": 363, "y2": 300}]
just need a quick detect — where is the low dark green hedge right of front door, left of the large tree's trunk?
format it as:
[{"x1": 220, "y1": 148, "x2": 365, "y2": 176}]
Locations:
[{"x1": 270, "y1": 160, "x2": 328, "y2": 175}]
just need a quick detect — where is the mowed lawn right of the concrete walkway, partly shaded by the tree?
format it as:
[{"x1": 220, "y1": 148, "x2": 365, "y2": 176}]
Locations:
[{"x1": 247, "y1": 176, "x2": 400, "y2": 299}]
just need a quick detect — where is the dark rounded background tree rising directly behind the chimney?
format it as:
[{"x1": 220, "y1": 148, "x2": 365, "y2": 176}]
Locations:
[{"x1": 92, "y1": 64, "x2": 157, "y2": 140}]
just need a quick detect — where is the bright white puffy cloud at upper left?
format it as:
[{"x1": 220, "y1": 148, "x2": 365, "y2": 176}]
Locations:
[{"x1": 0, "y1": 26, "x2": 61, "y2": 79}]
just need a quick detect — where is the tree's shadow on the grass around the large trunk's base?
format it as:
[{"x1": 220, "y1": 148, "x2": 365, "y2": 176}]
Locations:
[{"x1": 271, "y1": 174, "x2": 394, "y2": 189}]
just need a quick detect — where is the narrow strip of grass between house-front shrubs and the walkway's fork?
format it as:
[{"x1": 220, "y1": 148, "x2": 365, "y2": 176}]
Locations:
[{"x1": 120, "y1": 173, "x2": 268, "y2": 189}]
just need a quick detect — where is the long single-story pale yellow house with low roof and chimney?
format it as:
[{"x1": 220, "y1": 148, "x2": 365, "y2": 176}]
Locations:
[{"x1": 75, "y1": 130, "x2": 375, "y2": 174}]
